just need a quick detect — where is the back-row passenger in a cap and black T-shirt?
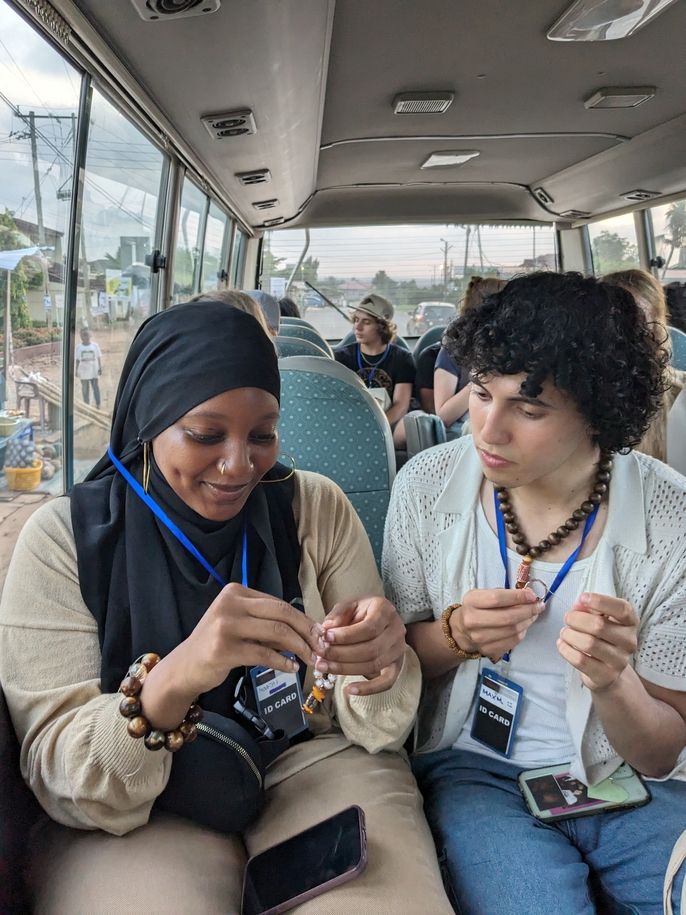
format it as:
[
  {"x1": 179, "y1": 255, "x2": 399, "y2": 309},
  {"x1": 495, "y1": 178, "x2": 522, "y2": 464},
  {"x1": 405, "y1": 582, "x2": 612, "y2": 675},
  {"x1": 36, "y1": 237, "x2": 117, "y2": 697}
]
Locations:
[{"x1": 334, "y1": 294, "x2": 415, "y2": 426}]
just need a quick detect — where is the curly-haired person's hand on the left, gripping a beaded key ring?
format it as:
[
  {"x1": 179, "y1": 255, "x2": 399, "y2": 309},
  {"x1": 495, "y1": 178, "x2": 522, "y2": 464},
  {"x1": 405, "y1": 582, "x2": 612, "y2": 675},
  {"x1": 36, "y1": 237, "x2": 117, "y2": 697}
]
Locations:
[{"x1": 450, "y1": 588, "x2": 545, "y2": 659}]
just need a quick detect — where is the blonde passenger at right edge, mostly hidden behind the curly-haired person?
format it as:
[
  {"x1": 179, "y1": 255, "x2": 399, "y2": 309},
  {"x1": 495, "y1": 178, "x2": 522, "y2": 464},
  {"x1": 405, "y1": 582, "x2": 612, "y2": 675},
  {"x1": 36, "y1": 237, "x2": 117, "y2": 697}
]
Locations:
[{"x1": 603, "y1": 269, "x2": 686, "y2": 463}]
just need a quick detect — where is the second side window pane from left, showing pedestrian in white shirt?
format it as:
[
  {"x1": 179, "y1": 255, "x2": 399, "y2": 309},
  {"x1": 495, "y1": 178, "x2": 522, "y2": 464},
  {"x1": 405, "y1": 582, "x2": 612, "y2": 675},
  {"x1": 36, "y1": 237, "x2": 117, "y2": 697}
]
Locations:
[{"x1": 74, "y1": 90, "x2": 166, "y2": 481}]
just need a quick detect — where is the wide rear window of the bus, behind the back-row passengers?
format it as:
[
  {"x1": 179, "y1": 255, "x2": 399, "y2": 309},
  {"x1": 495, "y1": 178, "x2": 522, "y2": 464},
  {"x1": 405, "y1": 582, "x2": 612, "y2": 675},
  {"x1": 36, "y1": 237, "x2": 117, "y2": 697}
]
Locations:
[{"x1": 261, "y1": 225, "x2": 556, "y2": 340}]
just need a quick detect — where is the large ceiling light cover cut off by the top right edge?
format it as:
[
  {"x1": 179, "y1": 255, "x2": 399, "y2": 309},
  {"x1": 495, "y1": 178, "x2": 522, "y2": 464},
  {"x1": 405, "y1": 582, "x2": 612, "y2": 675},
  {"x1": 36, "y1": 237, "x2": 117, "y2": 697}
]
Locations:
[{"x1": 548, "y1": 0, "x2": 676, "y2": 41}]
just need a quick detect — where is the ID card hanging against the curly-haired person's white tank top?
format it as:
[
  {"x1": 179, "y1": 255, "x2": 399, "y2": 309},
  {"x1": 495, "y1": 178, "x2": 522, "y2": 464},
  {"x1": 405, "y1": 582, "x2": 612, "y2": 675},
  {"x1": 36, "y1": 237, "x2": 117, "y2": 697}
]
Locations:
[{"x1": 472, "y1": 669, "x2": 524, "y2": 757}]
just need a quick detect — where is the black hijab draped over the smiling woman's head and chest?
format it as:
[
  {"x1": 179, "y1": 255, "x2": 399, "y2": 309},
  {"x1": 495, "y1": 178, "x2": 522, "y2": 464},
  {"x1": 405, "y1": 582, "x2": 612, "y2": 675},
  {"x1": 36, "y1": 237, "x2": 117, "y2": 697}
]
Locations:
[{"x1": 71, "y1": 302, "x2": 300, "y2": 715}]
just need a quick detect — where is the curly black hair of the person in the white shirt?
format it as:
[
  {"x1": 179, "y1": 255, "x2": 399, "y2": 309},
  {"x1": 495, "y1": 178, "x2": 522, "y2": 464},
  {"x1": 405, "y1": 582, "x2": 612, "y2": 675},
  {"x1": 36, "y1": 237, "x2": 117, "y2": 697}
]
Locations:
[{"x1": 444, "y1": 273, "x2": 669, "y2": 452}]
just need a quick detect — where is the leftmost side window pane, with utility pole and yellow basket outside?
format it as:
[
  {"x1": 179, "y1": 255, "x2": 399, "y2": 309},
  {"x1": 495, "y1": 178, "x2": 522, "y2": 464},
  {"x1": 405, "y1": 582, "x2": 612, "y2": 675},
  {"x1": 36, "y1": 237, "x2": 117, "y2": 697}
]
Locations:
[{"x1": 0, "y1": 3, "x2": 81, "y2": 524}]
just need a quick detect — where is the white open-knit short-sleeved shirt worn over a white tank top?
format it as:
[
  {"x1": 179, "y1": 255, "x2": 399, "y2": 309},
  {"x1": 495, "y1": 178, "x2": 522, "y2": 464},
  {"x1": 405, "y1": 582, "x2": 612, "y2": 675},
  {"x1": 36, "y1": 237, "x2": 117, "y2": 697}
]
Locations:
[{"x1": 383, "y1": 436, "x2": 686, "y2": 784}]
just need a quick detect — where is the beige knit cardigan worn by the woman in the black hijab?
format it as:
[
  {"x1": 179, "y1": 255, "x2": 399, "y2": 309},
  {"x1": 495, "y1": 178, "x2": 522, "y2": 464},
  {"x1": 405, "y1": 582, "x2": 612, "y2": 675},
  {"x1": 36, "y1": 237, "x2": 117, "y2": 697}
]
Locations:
[{"x1": 0, "y1": 472, "x2": 421, "y2": 835}]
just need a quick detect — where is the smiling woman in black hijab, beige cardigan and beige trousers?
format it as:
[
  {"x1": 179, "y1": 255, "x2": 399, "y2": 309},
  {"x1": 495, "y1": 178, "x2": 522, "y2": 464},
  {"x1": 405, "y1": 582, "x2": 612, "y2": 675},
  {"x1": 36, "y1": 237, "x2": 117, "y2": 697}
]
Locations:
[{"x1": 0, "y1": 302, "x2": 450, "y2": 913}]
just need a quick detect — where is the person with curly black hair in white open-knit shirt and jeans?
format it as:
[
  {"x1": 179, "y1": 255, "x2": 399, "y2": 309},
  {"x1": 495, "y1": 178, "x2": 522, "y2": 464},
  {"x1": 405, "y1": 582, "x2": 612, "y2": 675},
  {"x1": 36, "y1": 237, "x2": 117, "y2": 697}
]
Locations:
[{"x1": 383, "y1": 273, "x2": 686, "y2": 915}]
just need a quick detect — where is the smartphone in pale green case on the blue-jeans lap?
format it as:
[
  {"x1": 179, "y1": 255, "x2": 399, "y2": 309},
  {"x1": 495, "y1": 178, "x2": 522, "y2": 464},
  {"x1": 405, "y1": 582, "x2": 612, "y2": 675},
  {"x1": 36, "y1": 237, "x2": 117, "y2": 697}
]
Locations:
[{"x1": 517, "y1": 763, "x2": 650, "y2": 823}]
